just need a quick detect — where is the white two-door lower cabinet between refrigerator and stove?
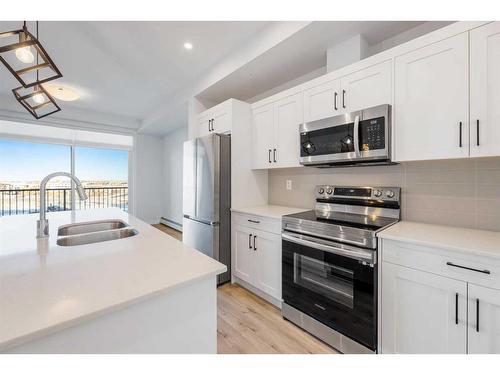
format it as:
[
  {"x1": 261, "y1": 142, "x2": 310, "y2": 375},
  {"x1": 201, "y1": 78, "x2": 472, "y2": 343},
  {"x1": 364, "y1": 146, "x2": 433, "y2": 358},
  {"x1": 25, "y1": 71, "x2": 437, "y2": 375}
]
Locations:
[{"x1": 231, "y1": 215, "x2": 281, "y2": 302}]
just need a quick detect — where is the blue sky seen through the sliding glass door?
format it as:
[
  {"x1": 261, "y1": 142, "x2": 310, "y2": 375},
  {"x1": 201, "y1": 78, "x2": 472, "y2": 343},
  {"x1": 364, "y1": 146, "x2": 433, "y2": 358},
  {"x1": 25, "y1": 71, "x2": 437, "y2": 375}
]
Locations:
[{"x1": 0, "y1": 139, "x2": 128, "y2": 182}]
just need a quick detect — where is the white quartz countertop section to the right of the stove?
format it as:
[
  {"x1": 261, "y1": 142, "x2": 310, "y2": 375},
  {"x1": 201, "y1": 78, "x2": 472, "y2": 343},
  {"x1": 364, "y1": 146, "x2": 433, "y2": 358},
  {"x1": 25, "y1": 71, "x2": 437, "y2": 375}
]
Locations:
[{"x1": 378, "y1": 221, "x2": 500, "y2": 258}]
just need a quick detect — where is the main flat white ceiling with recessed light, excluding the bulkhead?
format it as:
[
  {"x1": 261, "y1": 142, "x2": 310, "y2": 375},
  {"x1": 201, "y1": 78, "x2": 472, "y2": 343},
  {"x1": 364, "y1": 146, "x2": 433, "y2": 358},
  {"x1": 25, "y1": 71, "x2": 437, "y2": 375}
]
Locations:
[{"x1": 0, "y1": 22, "x2": 269, "y2": 126}]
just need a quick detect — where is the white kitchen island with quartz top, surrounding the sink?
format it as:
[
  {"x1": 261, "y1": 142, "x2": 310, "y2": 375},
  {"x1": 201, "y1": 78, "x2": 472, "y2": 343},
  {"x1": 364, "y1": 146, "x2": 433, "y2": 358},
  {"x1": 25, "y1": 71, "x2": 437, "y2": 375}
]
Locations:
[{"x1": 0, "y1": 208, "x2": 226, "y2": 353}]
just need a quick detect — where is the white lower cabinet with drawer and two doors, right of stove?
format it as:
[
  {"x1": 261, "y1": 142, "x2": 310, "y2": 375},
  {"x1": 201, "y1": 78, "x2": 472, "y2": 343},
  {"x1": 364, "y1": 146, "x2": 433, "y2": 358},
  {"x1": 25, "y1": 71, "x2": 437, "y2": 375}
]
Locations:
[{"x1": 379, "y1": 239, "x2": 500, "y2": 354}]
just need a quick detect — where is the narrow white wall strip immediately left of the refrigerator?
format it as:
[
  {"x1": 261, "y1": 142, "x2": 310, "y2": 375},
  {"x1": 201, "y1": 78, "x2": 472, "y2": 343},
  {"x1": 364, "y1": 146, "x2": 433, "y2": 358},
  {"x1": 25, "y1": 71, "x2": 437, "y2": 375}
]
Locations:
[{"x1": 162, "y1": 126, "x2": 188, "y2": 226}]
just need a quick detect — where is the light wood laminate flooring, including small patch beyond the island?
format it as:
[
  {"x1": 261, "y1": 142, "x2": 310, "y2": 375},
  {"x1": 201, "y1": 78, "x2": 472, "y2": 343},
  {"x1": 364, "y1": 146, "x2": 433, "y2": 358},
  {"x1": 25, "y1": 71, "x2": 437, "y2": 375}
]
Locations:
[{"x1": 148, "y1": 224, "x2": 337, "y2": 354}]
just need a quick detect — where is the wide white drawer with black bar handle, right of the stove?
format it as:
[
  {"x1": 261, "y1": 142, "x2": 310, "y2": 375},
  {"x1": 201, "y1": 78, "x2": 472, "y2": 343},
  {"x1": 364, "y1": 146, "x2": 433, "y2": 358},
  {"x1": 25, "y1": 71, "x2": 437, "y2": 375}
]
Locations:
[{"x1": 381, "y1": 239, "x2": 500, "y2": 289}]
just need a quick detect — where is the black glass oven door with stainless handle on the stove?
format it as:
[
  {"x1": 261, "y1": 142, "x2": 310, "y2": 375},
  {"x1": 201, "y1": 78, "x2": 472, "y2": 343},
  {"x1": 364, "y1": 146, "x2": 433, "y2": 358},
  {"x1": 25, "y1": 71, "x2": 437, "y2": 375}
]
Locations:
[{"x1": 282, "y1": 232, "x2": 377, "y2": 351}]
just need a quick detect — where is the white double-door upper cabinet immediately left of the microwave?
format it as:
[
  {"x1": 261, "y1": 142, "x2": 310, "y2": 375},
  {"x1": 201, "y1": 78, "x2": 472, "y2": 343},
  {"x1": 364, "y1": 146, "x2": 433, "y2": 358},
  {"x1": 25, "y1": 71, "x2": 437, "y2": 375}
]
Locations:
[{"x1": 252, "y1": 93, "x2": 303, "y2": 169}]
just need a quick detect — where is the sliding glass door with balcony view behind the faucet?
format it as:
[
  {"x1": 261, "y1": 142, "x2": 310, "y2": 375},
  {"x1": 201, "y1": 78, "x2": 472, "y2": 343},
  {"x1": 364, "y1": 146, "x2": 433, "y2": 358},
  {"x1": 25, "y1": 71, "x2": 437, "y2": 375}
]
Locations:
[{"x1": 0, "y1": 139, "x2": 129, "y2": 216}]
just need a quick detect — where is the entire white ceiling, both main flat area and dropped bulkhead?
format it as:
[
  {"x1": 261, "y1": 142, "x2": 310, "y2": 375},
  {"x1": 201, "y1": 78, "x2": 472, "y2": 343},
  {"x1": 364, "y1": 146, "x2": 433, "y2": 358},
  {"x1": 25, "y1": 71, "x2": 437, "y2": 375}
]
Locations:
[{"x1": 0, "y1": 21, "x2": 452, "y2": 135}]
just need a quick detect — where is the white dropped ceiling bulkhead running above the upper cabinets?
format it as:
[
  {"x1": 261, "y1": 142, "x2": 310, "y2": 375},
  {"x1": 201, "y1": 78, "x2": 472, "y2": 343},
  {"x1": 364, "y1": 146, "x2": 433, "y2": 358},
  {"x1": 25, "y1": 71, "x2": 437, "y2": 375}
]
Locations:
[{"x1": 195, "y1": 21, "x2": 449, "y2": 102}]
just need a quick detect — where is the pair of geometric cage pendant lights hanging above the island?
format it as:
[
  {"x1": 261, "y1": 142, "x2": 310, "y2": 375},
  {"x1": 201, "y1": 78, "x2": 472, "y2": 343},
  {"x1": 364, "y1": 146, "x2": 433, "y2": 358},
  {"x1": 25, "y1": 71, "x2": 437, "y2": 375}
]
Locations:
[{"x1": 0, "y1": 21, "x2": 62, "y2": 120}]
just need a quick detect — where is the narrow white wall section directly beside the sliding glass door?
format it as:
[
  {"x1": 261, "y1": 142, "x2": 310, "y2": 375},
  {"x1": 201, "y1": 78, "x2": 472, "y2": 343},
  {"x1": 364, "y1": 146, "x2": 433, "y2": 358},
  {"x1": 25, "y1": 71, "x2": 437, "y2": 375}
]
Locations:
[{"x1": 134, "y1": 134, "x2": 165, "y2": 224}]
